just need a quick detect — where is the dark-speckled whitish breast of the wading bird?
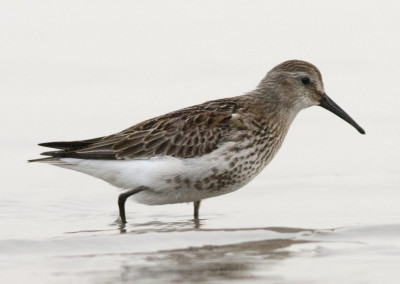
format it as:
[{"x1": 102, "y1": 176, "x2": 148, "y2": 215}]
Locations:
[{"x1": 168, "y1": 131, "x2": 282, "y2": 199}]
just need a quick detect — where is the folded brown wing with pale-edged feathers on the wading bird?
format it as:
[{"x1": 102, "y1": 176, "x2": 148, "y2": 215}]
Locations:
[{"x1": 42, "y1": 100, "x2": 238, "y2": 160}]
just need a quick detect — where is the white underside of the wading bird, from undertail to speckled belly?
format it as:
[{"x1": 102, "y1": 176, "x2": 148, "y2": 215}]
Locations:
[{"x1": 53, "y1": 143, "x2": 270, "y2": 205}]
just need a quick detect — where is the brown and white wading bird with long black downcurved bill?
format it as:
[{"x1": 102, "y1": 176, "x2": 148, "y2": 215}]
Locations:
[{"x1": 31, "y1": 60, "x2": 365, "y2": 223}]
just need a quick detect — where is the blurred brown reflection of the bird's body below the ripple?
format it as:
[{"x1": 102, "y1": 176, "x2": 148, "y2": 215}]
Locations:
[{"x1": 119, "y1": 235, "x2": 306, "y2": 283}]
